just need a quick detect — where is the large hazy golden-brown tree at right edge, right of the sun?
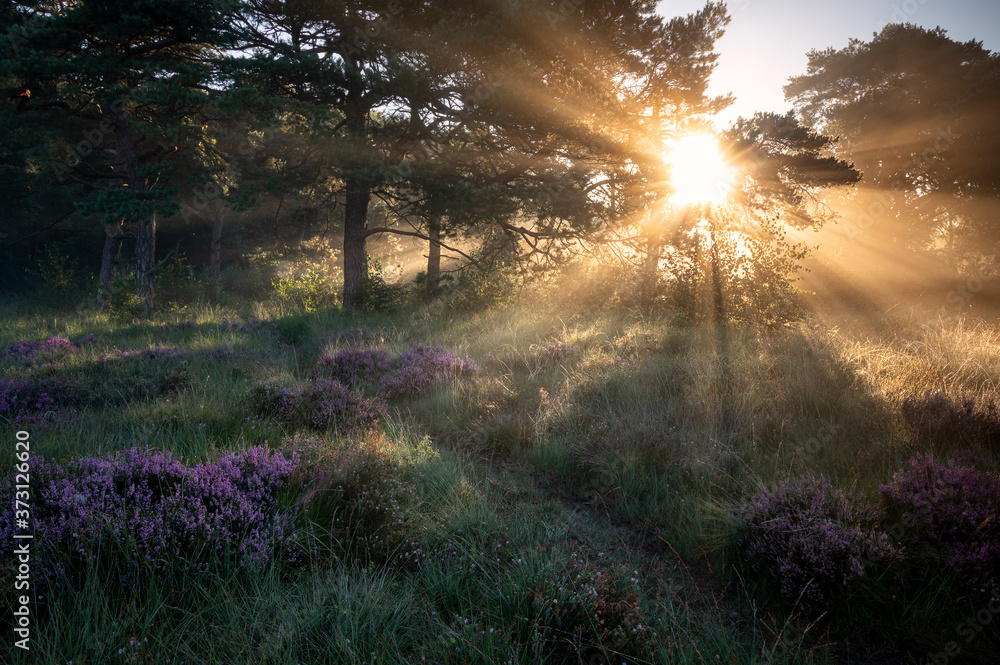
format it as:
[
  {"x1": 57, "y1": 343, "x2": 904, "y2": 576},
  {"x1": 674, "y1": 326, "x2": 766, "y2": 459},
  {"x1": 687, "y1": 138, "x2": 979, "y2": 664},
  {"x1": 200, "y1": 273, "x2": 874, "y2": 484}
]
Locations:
[{"x1": 785, "y1": 24, "x2": 1000, "y2": 268}]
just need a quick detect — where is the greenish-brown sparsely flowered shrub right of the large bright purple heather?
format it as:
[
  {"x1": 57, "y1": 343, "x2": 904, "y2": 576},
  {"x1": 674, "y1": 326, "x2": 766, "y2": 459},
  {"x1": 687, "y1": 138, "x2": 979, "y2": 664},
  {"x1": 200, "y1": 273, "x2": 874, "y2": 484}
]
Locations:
[{"x1": 293, "y1": 438, "x2": 416, "y2": 557}]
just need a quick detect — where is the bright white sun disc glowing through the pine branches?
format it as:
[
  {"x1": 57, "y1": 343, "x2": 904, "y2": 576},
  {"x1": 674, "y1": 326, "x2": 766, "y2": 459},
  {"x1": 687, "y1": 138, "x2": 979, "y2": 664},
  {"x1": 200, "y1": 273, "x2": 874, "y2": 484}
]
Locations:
[{"x1": 666, "y1": 134, "x2": 736, "y2": 206}]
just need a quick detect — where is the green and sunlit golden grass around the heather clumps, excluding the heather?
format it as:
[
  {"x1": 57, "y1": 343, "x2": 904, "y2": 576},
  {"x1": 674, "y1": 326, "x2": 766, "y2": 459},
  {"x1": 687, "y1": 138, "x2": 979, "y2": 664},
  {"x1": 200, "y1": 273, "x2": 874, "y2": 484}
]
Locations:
[{"x1": 0, "y1": 294, "x2": 1000, "y2": 665}]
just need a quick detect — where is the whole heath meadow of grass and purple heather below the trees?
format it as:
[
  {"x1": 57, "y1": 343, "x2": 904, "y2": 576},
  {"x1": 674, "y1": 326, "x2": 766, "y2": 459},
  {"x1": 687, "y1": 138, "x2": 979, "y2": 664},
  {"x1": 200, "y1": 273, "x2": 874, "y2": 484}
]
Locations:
[{"x1": 0, "y1": 284, "x2": 1000, "y2": 665}]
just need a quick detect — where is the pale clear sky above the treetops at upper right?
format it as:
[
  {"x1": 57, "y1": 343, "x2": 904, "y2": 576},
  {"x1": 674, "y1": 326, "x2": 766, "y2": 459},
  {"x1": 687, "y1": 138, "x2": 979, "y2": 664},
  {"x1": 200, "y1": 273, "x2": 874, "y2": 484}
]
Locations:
[{"x1": 659, "y1": 0, "x2": 1000, "y2": 127}]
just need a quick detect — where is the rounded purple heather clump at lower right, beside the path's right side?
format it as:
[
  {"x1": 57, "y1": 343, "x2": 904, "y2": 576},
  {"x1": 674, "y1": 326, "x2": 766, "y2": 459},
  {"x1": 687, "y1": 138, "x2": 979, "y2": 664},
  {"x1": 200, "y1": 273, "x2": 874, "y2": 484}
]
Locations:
[{"x1": 736, "y1": 477, "x2": 899, "y2": 607}]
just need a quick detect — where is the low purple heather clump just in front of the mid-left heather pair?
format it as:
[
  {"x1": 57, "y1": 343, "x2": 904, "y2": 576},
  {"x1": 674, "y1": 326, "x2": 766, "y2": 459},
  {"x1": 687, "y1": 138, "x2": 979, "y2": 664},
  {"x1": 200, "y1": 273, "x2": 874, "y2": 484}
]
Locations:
[{"x1": 251, "y1": 378, "x2": 384, "y2": 430}]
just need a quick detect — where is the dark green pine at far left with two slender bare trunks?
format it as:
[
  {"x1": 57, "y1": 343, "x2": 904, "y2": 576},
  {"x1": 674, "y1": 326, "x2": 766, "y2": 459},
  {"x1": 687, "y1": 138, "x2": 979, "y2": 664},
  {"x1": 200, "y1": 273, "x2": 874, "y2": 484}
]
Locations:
[{"x1": 0, "y1": 0, "x2": 238, "y2": 314}]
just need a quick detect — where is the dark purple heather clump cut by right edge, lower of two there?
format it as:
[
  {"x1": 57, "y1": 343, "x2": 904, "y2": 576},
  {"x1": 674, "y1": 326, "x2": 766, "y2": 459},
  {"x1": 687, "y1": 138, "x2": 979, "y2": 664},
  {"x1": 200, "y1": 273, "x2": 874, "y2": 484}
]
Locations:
[{"x1": 880, "y1": 456, "x2": 1000, "y2": 591}]
